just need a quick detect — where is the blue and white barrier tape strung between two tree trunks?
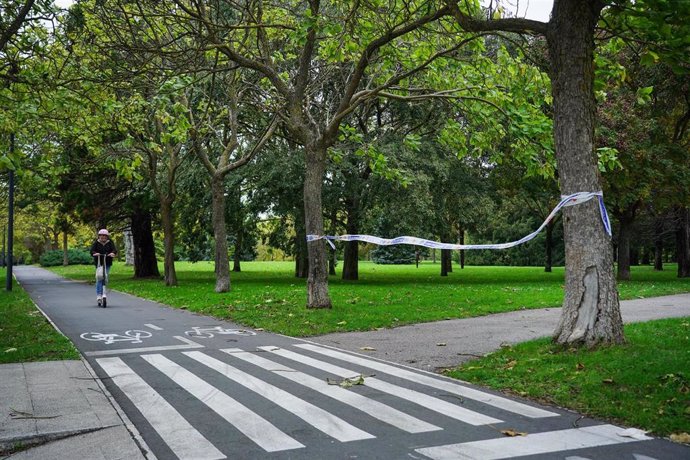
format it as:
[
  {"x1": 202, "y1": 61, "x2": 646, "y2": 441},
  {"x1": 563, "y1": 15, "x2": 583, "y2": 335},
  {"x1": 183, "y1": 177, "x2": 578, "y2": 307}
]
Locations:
[{"x1": 307, "y1": 192, "x2": 611, "y2": 250}]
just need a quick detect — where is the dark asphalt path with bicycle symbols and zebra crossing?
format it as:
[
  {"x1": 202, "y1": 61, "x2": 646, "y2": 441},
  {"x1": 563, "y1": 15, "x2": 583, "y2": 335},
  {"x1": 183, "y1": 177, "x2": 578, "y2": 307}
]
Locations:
[{"x1": 15, "y1": 267, "x2": 690, "y2": 460}]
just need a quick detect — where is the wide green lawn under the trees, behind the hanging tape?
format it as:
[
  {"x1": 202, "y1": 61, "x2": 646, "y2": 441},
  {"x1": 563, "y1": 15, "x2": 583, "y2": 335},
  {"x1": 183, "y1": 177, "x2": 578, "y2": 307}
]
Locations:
[{"x1": 52, "y1": 262, "x2": 690, "y2": 337}]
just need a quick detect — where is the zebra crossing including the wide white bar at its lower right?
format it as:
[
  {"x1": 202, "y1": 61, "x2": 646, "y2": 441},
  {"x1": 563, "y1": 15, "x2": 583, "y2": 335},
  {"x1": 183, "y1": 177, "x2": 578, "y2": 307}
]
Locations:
[{"x1": 93, "y1": 342, "x2": 651, "y2": 460}]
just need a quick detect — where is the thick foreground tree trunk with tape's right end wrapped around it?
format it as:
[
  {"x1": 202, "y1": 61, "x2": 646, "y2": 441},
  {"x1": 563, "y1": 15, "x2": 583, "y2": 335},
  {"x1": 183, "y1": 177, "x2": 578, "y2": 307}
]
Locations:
[{"x1": 547, "y1": 0, "x2": 625, "y2": 347}]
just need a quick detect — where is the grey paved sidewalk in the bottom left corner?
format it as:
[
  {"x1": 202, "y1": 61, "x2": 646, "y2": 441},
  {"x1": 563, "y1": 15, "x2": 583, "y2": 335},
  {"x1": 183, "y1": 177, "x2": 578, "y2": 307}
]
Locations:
[{"x1": 0, "y1": 361, "x2": 144, "y2": 460}]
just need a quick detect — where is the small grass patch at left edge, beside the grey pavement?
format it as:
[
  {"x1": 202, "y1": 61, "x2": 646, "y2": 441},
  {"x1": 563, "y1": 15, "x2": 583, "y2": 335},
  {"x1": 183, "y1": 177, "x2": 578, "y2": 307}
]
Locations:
[{"x1": 0, "y1": 268, "x2": 79, "y2": 364}]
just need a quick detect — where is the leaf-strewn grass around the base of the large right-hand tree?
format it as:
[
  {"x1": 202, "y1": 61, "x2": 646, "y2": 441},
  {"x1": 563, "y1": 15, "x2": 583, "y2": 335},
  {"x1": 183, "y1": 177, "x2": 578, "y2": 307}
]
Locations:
[{"x1": 446, "y1": 318, "x2": 690, "y2": 436}]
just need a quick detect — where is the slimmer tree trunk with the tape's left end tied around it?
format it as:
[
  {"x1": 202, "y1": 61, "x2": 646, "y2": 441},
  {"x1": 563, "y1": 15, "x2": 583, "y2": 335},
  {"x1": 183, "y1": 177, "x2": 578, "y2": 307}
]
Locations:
[{"x1": 304, "y1": 145, "x2": 332, "y2": 308}]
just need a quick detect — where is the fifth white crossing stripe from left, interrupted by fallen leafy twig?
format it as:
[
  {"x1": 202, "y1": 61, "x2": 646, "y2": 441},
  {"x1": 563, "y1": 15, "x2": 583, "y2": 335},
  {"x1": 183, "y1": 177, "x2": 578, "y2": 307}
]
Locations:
[{"x1": 256, "y1": 347, "x2": 503, "y2": 425}]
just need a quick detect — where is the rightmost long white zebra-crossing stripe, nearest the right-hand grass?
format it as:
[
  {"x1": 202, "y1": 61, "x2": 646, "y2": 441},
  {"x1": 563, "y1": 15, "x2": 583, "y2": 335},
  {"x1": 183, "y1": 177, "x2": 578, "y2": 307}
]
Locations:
[{"x1": 295, "y1": 343, "x2": 558, "y2": 418}]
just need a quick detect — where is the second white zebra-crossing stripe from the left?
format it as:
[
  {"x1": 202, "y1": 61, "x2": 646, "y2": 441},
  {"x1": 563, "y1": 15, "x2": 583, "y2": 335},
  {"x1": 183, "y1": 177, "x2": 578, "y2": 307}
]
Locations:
[{"x1": 142, "y1": 354, "x2": 304, "y2": 452}]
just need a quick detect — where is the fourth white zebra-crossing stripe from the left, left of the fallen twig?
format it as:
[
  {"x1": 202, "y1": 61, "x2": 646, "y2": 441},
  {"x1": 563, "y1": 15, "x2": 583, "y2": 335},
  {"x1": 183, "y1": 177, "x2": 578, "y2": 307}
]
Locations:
[{"x1": 221, "y1": 348, "x2": 442, "y2": 433}]
